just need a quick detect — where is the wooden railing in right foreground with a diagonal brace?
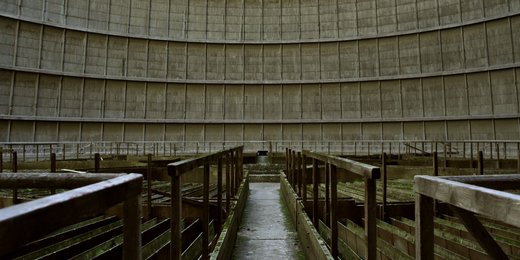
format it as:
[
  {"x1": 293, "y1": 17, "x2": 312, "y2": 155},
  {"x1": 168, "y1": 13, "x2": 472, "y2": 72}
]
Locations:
[{"x1": 414, "y1": 174, "x2": 520, "y2": 259}]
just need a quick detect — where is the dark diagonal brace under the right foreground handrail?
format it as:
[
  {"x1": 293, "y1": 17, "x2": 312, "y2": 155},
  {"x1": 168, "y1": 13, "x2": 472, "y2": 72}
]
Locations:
[{"x1": 450, "y1": 207, "x2": 508, "y2": 259}]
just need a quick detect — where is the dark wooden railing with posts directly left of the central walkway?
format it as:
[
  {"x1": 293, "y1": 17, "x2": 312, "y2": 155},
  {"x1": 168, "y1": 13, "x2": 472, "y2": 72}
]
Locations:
[{"x1": 168, "y1": 146, "x2": 244, "y2": 260}]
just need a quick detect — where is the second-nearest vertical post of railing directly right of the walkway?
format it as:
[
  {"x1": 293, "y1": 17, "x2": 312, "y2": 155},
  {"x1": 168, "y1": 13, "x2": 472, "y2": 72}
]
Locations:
[{"x1": 330, "y1": 165, "x2": 338, "y2": 258}]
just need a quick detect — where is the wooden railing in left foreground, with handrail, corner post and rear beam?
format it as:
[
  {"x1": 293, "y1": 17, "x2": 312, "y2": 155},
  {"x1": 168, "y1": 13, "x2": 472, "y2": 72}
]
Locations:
[{"x1": 0, "y1": 173, "x2": 143, "y2": 259}]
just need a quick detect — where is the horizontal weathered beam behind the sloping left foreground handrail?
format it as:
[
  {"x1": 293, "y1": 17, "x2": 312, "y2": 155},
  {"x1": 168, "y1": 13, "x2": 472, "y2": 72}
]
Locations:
[{"x1": 0, "y1": 172, "x2": 125, "y2": 189}]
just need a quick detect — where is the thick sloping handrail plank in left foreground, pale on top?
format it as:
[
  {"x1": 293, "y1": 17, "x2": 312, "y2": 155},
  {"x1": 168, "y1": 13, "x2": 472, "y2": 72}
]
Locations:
[{"x1": 0, "y1": 174, "x2": 143, "y2": 255}]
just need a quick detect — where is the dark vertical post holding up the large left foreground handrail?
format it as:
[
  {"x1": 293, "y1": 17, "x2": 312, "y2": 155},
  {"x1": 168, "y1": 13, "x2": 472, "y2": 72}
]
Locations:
[{"x1": 123, "y1": 194, "x2": 142, "y2": 260}]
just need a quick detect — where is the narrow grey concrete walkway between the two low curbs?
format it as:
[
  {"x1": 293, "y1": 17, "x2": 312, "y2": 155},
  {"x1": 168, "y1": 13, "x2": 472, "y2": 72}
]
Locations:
[{"x1": 233, "y1": 183, "x2": 305, "y2": 260}]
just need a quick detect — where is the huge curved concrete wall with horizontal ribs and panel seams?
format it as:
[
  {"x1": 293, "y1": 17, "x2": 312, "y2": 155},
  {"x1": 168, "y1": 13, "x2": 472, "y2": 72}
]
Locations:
[{"x1": 0, "y1": 0, "x2": 520, "y2": 142}]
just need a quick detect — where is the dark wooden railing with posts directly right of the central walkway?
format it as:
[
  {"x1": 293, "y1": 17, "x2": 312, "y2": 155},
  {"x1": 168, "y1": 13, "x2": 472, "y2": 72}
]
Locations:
[{"x1": 286, "y1": 149, "x2": 381, "y2": 259}]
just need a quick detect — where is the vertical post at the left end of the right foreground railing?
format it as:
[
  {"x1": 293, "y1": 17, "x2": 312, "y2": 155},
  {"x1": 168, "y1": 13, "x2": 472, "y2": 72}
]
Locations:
[{"x1": 415, "y1": 193, "x2": 434, "y2": 260}]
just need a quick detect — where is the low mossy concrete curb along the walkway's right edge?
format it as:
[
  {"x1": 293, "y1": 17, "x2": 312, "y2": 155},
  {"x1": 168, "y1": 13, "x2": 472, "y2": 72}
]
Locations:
[{"x1": 280, "y1": 174, "x2": 334, "y2": 259}]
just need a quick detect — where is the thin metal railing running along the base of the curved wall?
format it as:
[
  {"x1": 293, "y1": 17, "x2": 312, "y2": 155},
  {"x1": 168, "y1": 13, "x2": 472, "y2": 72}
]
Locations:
[{"x1": 0, "y1": 140, "x2": 520, "y2": 161}]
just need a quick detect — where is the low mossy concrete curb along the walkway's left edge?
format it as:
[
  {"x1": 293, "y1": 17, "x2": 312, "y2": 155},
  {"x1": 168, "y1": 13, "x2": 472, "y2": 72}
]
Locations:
[{"x1": 210, "y1": 175, "x2": 249, "y2": 260}]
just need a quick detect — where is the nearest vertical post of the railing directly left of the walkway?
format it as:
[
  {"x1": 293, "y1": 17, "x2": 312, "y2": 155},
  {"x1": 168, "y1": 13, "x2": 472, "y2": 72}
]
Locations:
[{"x1": 168, "y1": 168, "x2": 182, "y2": 260}]
